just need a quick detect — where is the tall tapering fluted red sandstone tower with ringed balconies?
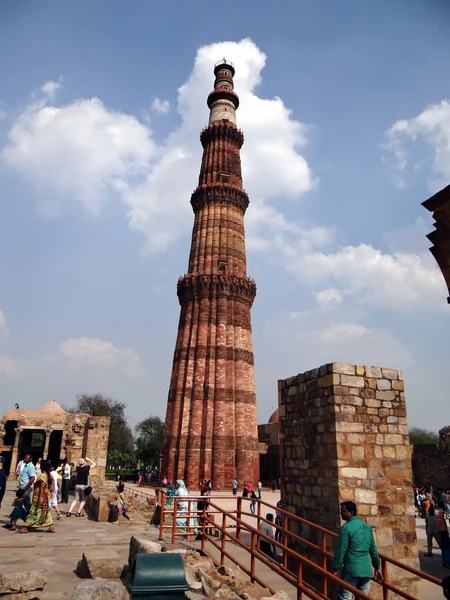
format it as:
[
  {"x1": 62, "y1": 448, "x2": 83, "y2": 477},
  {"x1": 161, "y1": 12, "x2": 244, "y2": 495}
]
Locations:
[{"x1": 162, "y1": 59, "x2": 259, "y2": 489}]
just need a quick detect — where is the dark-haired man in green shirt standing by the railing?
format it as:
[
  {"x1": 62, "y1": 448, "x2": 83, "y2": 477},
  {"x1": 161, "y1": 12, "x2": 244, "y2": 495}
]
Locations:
[{"x1": 333, "y1": 501, "x2": 382, "y2": 600}]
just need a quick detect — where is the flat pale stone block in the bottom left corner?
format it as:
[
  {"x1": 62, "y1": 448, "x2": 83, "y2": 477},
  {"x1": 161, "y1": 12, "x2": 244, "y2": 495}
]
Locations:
[{"x1": 0, "y1": 565, "x2": 48, "y2": 600}]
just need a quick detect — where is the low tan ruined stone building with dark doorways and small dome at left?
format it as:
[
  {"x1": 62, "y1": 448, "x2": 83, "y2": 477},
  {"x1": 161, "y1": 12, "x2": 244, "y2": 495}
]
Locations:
[{"x1": 0, "y1": 400, "x2": 110, "y2": 478}]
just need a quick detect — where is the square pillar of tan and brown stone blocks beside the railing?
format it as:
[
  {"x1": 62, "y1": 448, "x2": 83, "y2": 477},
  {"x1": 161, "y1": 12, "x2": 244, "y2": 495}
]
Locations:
[{"x1": 278, "y1": 363, "x2": 419, "y2": 597}]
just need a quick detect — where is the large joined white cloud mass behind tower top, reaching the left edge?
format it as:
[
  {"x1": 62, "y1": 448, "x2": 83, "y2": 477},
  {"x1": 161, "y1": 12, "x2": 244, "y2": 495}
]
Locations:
[{"x1": 2, "y1": 39, "x2": 314, "y2": 252}]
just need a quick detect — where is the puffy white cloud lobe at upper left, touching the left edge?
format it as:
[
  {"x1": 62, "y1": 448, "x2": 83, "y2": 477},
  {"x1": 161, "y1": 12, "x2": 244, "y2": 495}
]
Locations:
[{"x1": 2, "y1": 82, "x2": 157, "y2": 216}]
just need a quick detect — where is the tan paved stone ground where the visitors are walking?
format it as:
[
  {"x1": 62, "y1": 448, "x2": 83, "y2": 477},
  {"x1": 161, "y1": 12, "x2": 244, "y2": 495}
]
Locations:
[{"x1": 0, "y1": 484, "x2": 442, "y2": 600}]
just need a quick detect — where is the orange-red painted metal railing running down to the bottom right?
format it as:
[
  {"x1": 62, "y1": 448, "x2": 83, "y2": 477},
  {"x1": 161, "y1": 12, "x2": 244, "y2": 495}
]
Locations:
[{"x1": 157, "y1": 490, "x2": 442, "y2": 600}]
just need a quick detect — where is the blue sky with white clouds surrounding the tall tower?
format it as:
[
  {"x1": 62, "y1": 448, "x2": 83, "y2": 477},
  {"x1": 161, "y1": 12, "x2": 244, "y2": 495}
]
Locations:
[{"x1": 0, "y1": 0, "x2": 450, "y2": 430}]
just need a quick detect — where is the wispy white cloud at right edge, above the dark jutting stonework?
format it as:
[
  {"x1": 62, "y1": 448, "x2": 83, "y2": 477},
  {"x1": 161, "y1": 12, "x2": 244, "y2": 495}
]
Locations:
[{"x1": 385, "y1": 100, "x2": 450, "y2": 192}]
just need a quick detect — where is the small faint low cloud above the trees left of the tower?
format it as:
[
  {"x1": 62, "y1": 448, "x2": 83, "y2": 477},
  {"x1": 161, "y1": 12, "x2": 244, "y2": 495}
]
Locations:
[{"x1": 56, "y1": 337, "x2": 143, "y2": 377}]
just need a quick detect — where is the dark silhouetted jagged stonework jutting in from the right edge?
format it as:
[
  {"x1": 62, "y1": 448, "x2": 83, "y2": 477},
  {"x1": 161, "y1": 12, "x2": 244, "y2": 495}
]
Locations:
[{"x1": 422, "y1": 185, "x2": 450, "y2": 303}]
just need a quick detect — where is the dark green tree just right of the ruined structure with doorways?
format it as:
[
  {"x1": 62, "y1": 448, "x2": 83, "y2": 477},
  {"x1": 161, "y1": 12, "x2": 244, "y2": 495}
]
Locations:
[{"x1": 66, "y1": 394, "x2": 134, "y2": 454}]
